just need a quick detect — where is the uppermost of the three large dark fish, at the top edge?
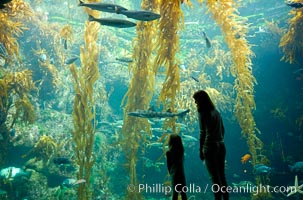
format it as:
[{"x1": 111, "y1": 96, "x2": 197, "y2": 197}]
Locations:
[{"x1": 78, "y1": 0, "x2": 127, "y2": 13}]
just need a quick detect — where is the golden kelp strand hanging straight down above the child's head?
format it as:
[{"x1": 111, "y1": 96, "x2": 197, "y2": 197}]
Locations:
[{"x1": 155, "y1": 0, "x2": 184, "y2": 134}]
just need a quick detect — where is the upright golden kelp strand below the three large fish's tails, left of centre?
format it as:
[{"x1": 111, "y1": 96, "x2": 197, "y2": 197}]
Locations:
[{"x1": 70, "y1": 3, "x2": 100, "y2": 200}]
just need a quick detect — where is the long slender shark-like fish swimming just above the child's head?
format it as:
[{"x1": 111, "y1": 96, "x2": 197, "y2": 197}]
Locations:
[{"x1": 128, "y1": 109, "x2": 189, "y2": 118}]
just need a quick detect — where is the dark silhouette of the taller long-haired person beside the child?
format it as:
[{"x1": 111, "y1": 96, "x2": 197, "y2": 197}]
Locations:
[{"x1": 193, "y1": 90, "x2": 229, "y2": 200}]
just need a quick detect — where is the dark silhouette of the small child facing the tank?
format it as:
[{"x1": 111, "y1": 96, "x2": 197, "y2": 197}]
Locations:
[{"x1": 166, "y1": 134, "x2": 187, "y2": 200}]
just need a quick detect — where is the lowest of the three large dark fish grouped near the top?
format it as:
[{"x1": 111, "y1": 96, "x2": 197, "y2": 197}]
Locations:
[{"x1": 88, "y1": 15, "x2": 137, "y2": 28}]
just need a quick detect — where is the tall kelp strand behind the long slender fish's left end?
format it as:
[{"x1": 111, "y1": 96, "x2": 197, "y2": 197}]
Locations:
[{"x1": 121, "y1": 0, "x2": 158, "y2": 199}]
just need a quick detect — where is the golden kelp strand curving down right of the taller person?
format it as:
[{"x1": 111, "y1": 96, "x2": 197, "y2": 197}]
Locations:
[{"x1": 199, "y1": 0, "x2": 262, "y2": 164}]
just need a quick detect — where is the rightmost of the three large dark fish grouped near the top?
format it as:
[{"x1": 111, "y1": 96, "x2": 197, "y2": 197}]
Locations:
[{"x1": 117, "y1": 10, "x2": 161, "y2": 21}]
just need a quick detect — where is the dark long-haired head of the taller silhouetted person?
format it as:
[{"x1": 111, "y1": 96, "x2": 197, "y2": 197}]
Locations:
[{"x1": 193, "y1": 90, "x2": 215, "y2": 112}]
